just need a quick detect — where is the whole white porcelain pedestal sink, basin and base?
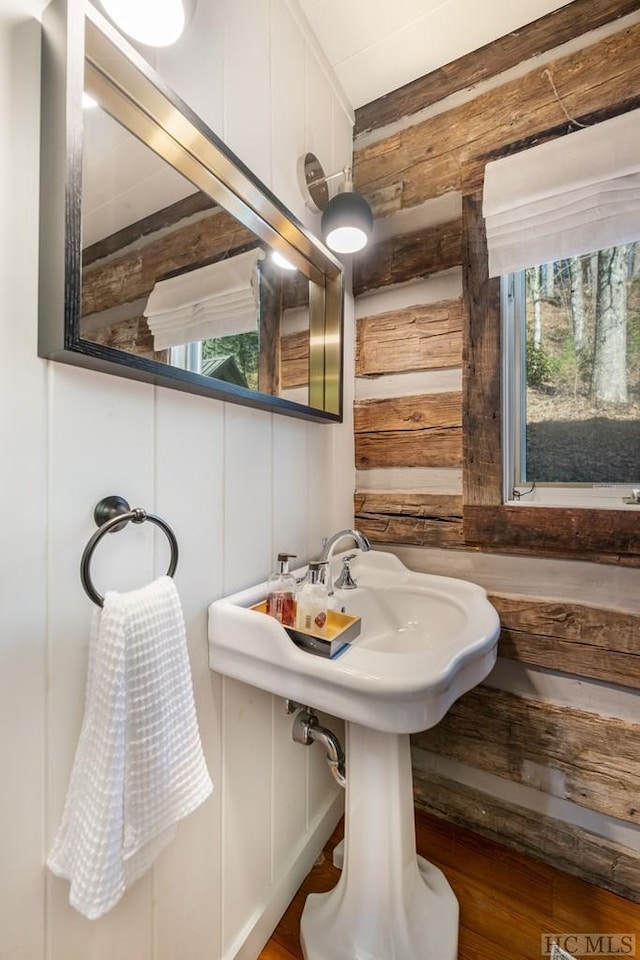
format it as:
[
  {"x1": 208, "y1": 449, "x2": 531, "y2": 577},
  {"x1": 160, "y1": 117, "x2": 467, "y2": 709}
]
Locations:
[{"x1": 209, "y1": 551, "x2": 499, "y2": 960}]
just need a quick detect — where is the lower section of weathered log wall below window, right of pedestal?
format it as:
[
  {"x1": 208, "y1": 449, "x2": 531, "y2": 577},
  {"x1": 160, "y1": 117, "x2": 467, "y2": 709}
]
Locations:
[{"x1": 413, "y1": 594, "x2": 640, "y2": 902}]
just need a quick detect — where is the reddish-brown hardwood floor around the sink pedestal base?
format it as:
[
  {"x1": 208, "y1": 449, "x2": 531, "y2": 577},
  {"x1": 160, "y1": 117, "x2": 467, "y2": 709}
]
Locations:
[{"x1": 260, "y1": 812, "x2": 640, "y2": 960}]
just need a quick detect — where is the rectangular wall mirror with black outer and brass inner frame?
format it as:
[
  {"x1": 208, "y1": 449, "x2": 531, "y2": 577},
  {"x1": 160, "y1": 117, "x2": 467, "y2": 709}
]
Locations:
[{"x1": 39, "y1": 0, "x2": 343, "y2": 421}]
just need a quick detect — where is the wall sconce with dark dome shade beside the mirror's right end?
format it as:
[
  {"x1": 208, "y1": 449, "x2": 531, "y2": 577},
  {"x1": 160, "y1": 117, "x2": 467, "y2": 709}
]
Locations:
[{"x1": 300, "y1": 153, "x2": 373, "y2": 253}]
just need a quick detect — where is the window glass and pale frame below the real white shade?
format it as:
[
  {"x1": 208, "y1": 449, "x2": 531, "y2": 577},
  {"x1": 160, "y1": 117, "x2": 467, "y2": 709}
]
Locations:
[{"x1": 502, "y1": 241, "x2": 640, "y2": 507}]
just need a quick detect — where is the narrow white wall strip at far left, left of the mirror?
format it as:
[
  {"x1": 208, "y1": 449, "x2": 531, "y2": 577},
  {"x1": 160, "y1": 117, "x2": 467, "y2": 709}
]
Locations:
[{"x1": 0, "y1": 15, "x2": 47, "y2": 960}]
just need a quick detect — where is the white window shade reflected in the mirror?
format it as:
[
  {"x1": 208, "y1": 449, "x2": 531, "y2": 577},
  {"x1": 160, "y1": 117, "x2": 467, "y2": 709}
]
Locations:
[{"x1": 144, "y1": 249, "x2": 264, "y2": 350}]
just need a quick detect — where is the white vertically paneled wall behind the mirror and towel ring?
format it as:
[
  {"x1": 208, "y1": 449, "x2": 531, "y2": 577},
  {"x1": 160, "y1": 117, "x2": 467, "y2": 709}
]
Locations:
[{"x1": 0, "y1": 0, "x2": 354, "y2": 960}]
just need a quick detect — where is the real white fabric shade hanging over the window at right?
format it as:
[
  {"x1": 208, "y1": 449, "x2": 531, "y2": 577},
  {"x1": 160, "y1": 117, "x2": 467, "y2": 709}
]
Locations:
[{"x1": 483, "y1": 110, "x2": 640, "y2": 277}]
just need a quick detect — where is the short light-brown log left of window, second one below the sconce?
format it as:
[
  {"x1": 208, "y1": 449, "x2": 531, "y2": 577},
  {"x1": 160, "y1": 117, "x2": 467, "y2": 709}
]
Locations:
[{"x1": 356, "y1": 297, "x2": 462, "y2": 377}]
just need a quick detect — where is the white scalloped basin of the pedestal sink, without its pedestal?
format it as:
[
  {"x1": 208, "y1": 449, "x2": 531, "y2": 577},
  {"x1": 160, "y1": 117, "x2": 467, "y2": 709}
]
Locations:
[{"x1": 209, "y1": 551, "x2": 499, "y2": 733}]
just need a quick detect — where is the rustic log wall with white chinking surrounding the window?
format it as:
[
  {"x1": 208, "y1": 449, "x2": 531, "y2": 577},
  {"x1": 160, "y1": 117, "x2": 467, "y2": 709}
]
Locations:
[{"x1": 354, "y1": 0, "x2": 640, "y2": 901}]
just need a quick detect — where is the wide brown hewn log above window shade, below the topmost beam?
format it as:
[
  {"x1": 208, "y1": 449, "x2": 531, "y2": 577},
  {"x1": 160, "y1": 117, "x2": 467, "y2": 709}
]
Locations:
[{"x1": 354, "y1": 8, "x2": 640, "y2": 209}]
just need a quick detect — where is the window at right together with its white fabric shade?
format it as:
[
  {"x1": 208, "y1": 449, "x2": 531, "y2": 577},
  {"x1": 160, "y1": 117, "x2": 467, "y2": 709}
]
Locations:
[{"x1": 483, "y1": 110, "x2": 640, "y2": 510}]
